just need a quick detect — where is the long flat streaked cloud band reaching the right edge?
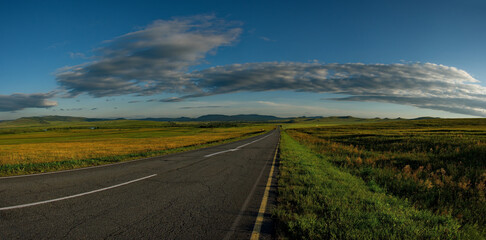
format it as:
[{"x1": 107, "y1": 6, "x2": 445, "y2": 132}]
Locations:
[{"x1": 188, "y1": 62, "x2": 486, "y2": 116}]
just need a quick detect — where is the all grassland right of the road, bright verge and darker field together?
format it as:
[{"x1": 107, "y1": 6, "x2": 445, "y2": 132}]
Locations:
[{"x1": 276, "y1": 119, "x2": 486, "y2": 239}]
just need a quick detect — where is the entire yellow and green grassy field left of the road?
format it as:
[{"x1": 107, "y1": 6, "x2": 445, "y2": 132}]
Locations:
[{"x1": 0, "y1": 120, "x2": 273, "y2": 175}]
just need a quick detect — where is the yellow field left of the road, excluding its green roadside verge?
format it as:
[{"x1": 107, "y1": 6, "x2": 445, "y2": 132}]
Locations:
[{"x1": 0, "y1": 126, "x2": 270, "y2": 165}]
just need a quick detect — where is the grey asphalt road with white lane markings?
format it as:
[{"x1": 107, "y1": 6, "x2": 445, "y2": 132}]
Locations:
[{"x1": 0, "y1": 130, "x2": 279, "y2": 239}]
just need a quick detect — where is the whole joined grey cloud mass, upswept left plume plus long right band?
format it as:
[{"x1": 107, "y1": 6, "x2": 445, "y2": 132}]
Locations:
[{"x1": 50, "y1": 16, "x2": 486, "y2": 116}]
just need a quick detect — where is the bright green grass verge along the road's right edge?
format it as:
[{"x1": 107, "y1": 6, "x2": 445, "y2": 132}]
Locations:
[{"x1": 274, "y1": 133, "x2": 481, "y2": 239}]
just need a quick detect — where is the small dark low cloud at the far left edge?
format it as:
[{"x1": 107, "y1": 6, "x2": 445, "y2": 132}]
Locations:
[{"x1": 0, "y1": 93, "x2": 57, "y2": 112}]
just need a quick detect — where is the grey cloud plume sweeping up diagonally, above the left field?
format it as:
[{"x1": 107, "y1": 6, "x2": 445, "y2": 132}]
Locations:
[{"x1": 56, "y1": 16, "x2": 241, "y2": 97}]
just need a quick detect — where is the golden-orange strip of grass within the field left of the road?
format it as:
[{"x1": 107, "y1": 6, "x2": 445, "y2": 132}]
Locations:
[{"x1": 0, "y1": 132, "x2": 244, "y2": 164}]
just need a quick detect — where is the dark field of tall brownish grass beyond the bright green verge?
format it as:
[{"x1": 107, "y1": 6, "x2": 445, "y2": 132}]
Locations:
[{"x1": 289, "y1": 119, "x2": 486, "y2": 237}]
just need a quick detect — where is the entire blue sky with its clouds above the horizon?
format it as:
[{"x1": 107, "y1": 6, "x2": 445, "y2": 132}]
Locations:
[{"x1": 0, "y1": 1, "x2": 486, "y2": 119}]
